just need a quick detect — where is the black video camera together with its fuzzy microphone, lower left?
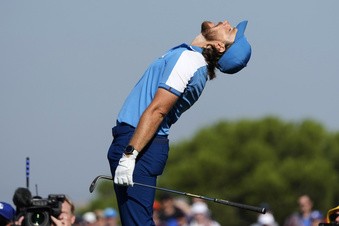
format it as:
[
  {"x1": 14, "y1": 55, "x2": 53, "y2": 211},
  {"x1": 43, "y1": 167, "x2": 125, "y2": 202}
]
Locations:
[{"x1": 13, "y1": 188, "x2": 66, "y2": 226}]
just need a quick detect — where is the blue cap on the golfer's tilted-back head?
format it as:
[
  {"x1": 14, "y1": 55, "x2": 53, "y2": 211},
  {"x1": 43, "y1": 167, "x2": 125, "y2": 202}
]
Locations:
[{"x1": 217, "y1": 20, "x2": 252, "y2": 74}]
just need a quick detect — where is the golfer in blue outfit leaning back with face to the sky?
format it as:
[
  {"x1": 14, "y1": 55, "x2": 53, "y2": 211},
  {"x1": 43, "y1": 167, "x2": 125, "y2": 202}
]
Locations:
[{"x1": 107, "y1": 21, "x2": 251, "y2": 226}]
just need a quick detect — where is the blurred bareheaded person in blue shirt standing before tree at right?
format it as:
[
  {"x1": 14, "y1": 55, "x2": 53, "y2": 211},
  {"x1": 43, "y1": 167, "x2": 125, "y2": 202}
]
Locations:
[{"x1": 284, "y1": 195, "x2": 317, "y2": 226}]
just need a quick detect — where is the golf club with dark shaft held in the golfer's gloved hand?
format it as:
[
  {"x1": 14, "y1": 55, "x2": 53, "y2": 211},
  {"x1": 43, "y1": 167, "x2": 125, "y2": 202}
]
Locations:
[{"x1": 89, "y1": 175, "x2": 266, "y2": 214}]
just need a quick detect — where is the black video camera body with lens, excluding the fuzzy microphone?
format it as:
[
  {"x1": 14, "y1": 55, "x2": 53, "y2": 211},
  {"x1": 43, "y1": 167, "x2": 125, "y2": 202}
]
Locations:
[{"x1": 21, "y1": 194, "x2": 65, "y2": 226}]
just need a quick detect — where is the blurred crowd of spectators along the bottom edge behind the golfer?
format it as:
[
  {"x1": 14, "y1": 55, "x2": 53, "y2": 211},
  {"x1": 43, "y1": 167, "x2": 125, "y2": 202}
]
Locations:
[{"x1": 0, "y1": 193, "x2": 339, "y2": 226}]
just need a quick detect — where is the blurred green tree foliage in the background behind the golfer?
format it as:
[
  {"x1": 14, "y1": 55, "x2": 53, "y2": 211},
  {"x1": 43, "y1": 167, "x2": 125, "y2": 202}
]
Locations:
[{"x1": 88, "y1": 117, "x2": 339, "y2": 226}]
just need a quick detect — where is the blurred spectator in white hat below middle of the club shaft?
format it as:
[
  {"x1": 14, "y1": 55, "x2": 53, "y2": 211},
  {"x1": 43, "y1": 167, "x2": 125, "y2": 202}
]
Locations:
[{"x1": 189, "y1": 201, "x2": 220, "y2": 226}]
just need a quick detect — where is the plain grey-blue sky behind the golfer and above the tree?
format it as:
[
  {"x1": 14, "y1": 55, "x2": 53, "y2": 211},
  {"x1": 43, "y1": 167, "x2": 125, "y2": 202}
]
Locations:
[{"x1": 0, "y1": 0, "x2": 339, "y2": 205}]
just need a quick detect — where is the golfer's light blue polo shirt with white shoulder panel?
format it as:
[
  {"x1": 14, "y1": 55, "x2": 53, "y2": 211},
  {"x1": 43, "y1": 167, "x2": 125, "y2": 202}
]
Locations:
[{"x1": 118, "y1": 44, "x2": 208, "y2": 135}]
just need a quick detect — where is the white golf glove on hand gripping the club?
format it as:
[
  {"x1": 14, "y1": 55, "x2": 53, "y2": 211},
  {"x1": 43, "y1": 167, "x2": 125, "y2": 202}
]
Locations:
[{"x1": 114, "y1": 151, "x2": 139, "y2": 186}]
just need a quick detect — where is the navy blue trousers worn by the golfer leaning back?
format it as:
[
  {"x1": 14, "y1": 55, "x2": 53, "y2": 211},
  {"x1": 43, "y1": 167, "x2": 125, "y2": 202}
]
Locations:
[{"x1": 107, "y1": 123, "x2": 169, "y2": 226}]
